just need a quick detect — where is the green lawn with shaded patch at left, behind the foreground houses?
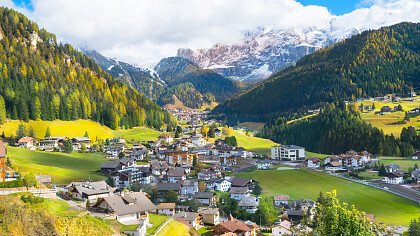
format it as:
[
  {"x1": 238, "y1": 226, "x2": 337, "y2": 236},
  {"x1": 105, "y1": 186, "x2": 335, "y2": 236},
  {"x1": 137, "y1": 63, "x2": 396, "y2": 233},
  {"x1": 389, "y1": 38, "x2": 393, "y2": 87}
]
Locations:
[{"x1": 7, "y1": 146, "x2": 108, "y2": 184}]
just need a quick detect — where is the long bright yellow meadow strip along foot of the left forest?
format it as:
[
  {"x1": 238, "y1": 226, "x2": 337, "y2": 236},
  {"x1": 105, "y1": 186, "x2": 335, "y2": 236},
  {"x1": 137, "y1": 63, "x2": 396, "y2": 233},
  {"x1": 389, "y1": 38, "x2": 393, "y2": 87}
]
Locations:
[{"x1": 0, "y1": 120, "x2": 162, "y2": 141}]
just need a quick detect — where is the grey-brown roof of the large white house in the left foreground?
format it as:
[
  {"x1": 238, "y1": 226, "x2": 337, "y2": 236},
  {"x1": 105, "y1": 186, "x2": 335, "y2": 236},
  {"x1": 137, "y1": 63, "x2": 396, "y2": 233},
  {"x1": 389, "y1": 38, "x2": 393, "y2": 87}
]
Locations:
[{"x1": 104, "y1": 192, "x2": 156, "y2": 215}]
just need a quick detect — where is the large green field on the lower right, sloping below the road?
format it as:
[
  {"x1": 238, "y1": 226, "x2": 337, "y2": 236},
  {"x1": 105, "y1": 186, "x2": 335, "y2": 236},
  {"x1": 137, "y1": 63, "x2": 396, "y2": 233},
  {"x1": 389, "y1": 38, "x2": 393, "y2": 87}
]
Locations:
[{"x1": 238, "y1": 169, "x2": 420, "y2": 226}]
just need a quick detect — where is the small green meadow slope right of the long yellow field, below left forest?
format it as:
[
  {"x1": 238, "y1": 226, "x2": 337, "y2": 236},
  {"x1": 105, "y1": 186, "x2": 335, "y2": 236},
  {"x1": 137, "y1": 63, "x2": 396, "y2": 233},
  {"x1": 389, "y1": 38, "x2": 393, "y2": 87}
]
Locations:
[{"x1": 112, "y1": 127, "x2": 162, "y2": 142}]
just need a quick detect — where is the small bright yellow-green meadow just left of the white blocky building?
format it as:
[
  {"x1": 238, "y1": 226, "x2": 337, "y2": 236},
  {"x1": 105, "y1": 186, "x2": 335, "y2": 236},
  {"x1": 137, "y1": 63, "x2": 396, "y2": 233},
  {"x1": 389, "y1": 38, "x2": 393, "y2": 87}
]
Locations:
[{"x1": 233, "y1": 130, "x2": 277, "y2": 155}]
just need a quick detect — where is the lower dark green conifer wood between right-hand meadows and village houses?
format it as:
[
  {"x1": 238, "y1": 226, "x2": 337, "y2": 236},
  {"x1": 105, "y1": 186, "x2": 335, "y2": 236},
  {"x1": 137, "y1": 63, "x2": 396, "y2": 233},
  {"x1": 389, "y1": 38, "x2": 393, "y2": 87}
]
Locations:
[{"x1": 261, "y1": 103, "x2": 420, "y2": 157}]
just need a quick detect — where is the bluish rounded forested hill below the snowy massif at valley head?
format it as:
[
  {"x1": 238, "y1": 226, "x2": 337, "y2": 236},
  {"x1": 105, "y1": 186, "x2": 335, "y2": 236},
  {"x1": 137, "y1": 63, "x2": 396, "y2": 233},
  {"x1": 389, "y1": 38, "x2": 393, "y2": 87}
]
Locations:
[{"x1": 155, "y1": 57, "x2": 239, "y2": 102}]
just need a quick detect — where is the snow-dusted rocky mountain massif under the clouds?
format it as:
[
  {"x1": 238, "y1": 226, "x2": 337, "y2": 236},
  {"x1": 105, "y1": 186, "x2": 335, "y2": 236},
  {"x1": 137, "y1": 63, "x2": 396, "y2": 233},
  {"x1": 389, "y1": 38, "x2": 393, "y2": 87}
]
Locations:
[{"x1": 177, "y1": 28, "x2": 359, "y2": 82}]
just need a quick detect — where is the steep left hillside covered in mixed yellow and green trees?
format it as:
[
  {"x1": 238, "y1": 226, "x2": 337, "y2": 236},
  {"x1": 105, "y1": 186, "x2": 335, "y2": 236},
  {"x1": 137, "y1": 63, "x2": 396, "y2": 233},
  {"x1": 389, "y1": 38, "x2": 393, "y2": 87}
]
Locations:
[{"x1": 0, "y1": 8, "x2": 174, "y2": 129}]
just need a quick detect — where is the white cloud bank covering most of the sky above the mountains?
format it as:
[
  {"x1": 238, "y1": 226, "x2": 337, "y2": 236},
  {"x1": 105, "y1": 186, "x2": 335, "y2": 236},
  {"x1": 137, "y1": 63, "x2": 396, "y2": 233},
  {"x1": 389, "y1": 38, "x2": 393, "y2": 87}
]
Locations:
[{"x1": 0, "y1": 0, "x2": 420, "y2": 64}]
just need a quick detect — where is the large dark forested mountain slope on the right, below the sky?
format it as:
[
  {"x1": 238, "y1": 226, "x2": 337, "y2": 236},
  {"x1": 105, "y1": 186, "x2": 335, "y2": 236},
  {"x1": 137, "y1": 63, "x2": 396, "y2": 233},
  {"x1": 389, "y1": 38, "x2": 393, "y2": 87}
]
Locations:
[{"x1": 214, "y1": 23, "x2": 420, "y2": 123}]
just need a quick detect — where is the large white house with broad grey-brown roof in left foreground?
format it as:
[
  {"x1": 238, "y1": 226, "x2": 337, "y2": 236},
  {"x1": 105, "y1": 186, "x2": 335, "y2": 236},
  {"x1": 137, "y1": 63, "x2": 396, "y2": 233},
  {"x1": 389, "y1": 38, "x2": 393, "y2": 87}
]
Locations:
[{"x1": 97, "y1": 192, "x2": 156, "y2": 224}]
